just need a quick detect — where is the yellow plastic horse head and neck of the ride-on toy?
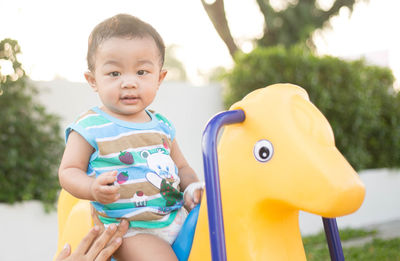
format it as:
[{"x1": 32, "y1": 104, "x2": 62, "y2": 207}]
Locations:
[{"x1": 189, "y1": 84, "x2": 365, "y2": 261}]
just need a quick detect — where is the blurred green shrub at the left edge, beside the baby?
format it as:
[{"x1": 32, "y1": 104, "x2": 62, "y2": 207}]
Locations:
[{"x1": 0, "y1": 39, "x2": 63, "y2": 206}]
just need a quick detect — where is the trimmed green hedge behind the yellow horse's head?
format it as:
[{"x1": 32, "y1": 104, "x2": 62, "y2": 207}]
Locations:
[{"x1": 225, "y1": 47, "x2": 400, "y2": 170}]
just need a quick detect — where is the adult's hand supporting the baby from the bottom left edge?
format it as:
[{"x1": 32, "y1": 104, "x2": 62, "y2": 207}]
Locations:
[{"x1": 55, "y1": 220, "x2": 129, "y2": 261}]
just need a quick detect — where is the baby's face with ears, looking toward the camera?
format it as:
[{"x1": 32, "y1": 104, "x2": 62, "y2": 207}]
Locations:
[{"x1": 91, "y1": 37, "x2": 166, "y2": 122}]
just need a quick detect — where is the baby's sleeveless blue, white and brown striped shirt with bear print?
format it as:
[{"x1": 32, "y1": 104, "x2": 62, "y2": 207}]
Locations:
[{"x1": 66, "y1": 107, "x2": 183, "y2": 228}]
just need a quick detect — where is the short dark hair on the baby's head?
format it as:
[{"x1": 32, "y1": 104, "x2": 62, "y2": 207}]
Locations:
[{"x1": 86, "y1": 14, "x2": 165, "y2": 71}]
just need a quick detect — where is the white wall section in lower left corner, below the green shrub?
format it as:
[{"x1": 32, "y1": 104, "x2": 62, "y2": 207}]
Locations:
[{"x1": 0, "y1": 201, "x2": 58, "y2": 261}]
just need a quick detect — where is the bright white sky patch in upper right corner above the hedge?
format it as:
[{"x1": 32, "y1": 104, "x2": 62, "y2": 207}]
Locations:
[{"x1": 317, "y1": 0, "x2": 400, "y2": 88}]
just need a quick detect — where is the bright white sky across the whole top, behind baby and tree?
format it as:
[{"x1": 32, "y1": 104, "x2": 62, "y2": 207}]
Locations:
[{"x1": 0, "y1": 0, "x2": 400, "y2": 83}]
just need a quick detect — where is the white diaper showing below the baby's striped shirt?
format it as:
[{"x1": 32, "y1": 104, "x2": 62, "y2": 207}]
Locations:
[{"x1": 124, "y1": 207, "x2": 188, "y2": 245}]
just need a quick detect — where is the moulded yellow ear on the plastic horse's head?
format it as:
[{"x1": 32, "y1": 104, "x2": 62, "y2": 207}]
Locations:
[{"x1": 291, "y1": 95, "x2": 335, "y2": 146}]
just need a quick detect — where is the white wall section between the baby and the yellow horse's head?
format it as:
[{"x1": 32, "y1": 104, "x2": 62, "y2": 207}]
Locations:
[{"x1": 151, "y1": 83, "x2": 223, "y2": 175}]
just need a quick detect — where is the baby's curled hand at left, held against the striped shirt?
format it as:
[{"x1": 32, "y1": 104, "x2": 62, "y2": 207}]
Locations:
[{"x1": 90, "y1": 171, "x2": 120, "y2": 204}]
